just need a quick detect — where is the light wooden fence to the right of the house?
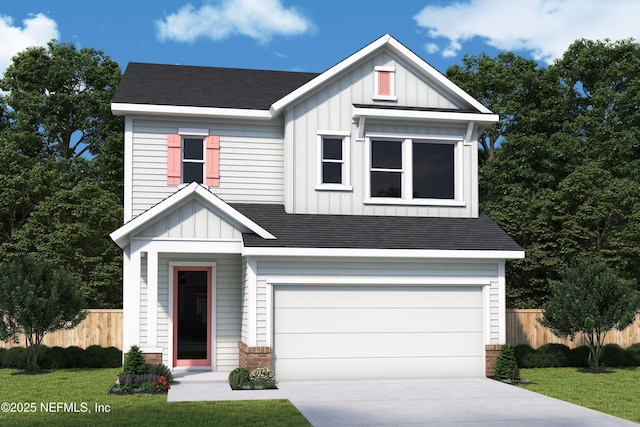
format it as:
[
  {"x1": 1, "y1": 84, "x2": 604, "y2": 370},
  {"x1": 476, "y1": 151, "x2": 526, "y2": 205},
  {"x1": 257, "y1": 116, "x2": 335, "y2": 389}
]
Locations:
[{"x1": 507, "y1": 309, "x2": 640, "y2": 348}]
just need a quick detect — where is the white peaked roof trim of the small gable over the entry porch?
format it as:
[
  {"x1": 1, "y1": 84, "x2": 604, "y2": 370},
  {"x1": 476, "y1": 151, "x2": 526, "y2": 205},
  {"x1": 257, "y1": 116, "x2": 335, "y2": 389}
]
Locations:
[{"x1": 110, "y1": 182, "x2": 275, "y2": 249}]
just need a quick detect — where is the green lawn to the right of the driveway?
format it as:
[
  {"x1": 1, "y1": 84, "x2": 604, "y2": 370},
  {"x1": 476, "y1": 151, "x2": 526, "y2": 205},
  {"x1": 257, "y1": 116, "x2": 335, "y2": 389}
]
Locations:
[{"x1": 520, "y1": 368, "x2": 640, "y2": 423}]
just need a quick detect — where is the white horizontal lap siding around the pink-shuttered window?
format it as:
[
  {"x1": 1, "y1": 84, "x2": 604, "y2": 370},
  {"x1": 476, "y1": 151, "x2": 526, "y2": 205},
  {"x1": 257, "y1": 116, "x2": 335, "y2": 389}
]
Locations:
[{"x1": 131, "y1": 118, "x2": 284, "y2": 217}]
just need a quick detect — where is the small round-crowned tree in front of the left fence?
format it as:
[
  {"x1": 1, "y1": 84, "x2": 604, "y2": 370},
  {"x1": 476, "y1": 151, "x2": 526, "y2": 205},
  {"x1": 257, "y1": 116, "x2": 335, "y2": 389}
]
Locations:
[{"x1": 0, "y1": 256, "x2": 87, "y2": 371}]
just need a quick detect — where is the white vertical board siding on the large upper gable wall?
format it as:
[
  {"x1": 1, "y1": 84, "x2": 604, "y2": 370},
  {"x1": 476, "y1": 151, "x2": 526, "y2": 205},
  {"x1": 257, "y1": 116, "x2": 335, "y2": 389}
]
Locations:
[{"x1": 285, "y1": 52, "x2": 478, "y2": 217}]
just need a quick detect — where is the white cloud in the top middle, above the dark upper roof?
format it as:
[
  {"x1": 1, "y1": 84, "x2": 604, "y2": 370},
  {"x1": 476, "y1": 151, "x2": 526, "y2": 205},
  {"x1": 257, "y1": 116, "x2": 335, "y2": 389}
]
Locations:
[{"x1": 156, "y1": 0, "x2": 315, "y2": 43}]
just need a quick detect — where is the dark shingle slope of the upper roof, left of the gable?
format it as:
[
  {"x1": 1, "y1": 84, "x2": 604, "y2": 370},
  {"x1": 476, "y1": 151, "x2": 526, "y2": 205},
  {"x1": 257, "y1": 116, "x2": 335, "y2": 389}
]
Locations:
[{"x1": 113, "y1": 62, "x2": 318, "y2": 110}]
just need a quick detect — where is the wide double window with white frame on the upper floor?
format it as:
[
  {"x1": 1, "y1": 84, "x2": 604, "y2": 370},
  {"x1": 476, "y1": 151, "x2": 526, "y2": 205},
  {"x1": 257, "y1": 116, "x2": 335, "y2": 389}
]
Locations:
[{"x1": 366, "y1": 136, "x2": 463, "y2": 205}]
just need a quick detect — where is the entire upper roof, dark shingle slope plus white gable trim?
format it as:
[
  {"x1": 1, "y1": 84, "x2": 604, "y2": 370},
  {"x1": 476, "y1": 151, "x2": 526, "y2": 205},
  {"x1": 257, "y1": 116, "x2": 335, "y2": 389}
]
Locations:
[{"x1": 111, "y1": 34, "x2": 497, "y2": 123}]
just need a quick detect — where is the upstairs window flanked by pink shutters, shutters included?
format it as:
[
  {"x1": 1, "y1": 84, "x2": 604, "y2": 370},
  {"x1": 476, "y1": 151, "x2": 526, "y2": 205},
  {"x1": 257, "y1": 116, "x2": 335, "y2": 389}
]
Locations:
[{"x1": 167, "y1": 129, "x2": 220, "y2": 186}]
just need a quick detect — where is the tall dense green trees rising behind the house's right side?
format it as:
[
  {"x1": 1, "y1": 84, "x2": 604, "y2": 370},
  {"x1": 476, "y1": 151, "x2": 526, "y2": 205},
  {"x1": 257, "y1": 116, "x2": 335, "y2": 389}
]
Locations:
[{"x1": 447, "y1": 40, "x2": 640, "y2": 308}]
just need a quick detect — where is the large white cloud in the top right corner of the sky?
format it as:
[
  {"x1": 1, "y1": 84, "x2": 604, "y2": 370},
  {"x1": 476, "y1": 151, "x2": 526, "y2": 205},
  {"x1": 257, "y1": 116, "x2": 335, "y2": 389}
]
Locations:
[{"x1": 414, "y1": 0, "x2": 640, "y2": 63}]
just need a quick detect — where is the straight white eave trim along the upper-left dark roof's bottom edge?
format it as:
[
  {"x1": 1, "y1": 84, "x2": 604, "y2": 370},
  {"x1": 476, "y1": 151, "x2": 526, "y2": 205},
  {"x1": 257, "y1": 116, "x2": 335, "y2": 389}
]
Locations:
[{"x1": 111, "y1": 103, "x2": 273, "y2": 120}]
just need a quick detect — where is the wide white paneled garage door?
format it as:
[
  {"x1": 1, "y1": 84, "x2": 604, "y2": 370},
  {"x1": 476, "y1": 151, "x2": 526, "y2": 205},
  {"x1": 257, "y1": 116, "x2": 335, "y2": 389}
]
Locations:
[{"x1": 273, "y1": 285, "x2": 484, "y2": 380}]
